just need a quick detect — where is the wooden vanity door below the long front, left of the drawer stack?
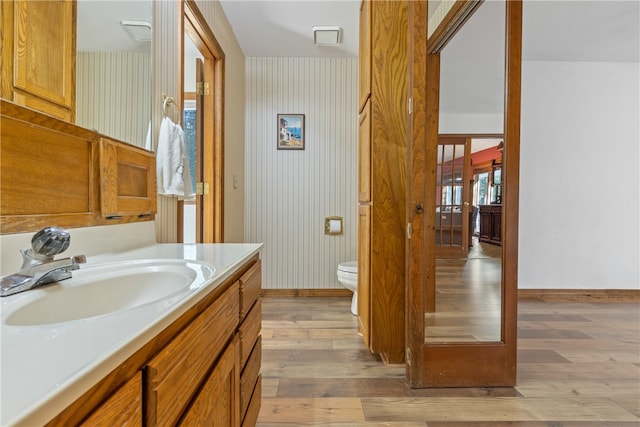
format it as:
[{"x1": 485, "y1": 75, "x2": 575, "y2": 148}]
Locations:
[{"x1": 179, "y1": 336, "x2": 240, "y2": 427}]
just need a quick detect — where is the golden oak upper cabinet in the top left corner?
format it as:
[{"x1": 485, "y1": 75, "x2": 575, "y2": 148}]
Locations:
[{"x1": 2, "y1": 0, "x2": 76, "y2": 123}]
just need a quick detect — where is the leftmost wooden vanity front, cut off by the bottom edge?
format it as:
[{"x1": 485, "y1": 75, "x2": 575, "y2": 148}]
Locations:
[{"x1": 80, "y1": 372, "x2": 142, "y2": 427}]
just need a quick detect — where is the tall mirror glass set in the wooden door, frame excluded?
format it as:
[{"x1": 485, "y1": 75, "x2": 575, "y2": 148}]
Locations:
[{"x1": 425, "y1": 1, "x2": 505, "y2": 343}]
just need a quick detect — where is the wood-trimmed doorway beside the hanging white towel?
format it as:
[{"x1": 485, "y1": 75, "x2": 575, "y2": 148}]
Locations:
[{"x1": 178, "y1": 1, "x2": 224, "y2": 243}]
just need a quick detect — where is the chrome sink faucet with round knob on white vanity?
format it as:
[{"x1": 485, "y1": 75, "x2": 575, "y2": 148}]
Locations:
[{"x1": 0, "y1": 227, "x2": 87, "y2": 297}]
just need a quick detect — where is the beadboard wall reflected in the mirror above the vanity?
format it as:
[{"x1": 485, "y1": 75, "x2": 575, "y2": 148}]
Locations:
[{"x1": 76, "y1": 52, "x2": 151, "y2": 148}]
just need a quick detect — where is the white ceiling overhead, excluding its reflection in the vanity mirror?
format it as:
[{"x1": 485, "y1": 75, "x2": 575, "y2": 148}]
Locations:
[{"x1": 221, "y1": 0, "x2": 640, "y2": 62}]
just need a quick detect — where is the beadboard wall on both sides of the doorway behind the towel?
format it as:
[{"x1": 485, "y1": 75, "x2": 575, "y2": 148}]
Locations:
[{"x1": 152, "y1": 0, "x2": 244, "y2": 243}]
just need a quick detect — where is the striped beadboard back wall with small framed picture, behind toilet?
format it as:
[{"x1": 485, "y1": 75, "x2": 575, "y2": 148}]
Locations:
[{"x1": 244, "y1": 58, "x2": 358, "y2": 289}]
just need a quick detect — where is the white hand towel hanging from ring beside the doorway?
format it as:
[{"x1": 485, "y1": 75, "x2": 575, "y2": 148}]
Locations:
[{"x1": 156, "y1": 117, "x2": 193, "y2": 198}]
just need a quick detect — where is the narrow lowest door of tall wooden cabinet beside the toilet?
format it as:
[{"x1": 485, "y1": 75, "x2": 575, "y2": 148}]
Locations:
[{"x1": 358, "y1": 204, "x2": 371, "y2": 347}]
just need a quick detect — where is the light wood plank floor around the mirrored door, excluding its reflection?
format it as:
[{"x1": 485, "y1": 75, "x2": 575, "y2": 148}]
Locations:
[{"x1": 257, "y1": 297, "x2": 640, "y2": 427}]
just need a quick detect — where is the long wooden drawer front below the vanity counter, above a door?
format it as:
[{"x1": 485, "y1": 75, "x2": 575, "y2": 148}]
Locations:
[{"x1": 146, "y1": 282, "x2": 239, "y2": 425}]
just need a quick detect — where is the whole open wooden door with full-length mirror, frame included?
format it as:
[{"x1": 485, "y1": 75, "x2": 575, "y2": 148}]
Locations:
[{"x1": 407, "y1": 0, "x2": 522, "y2": 387}]
